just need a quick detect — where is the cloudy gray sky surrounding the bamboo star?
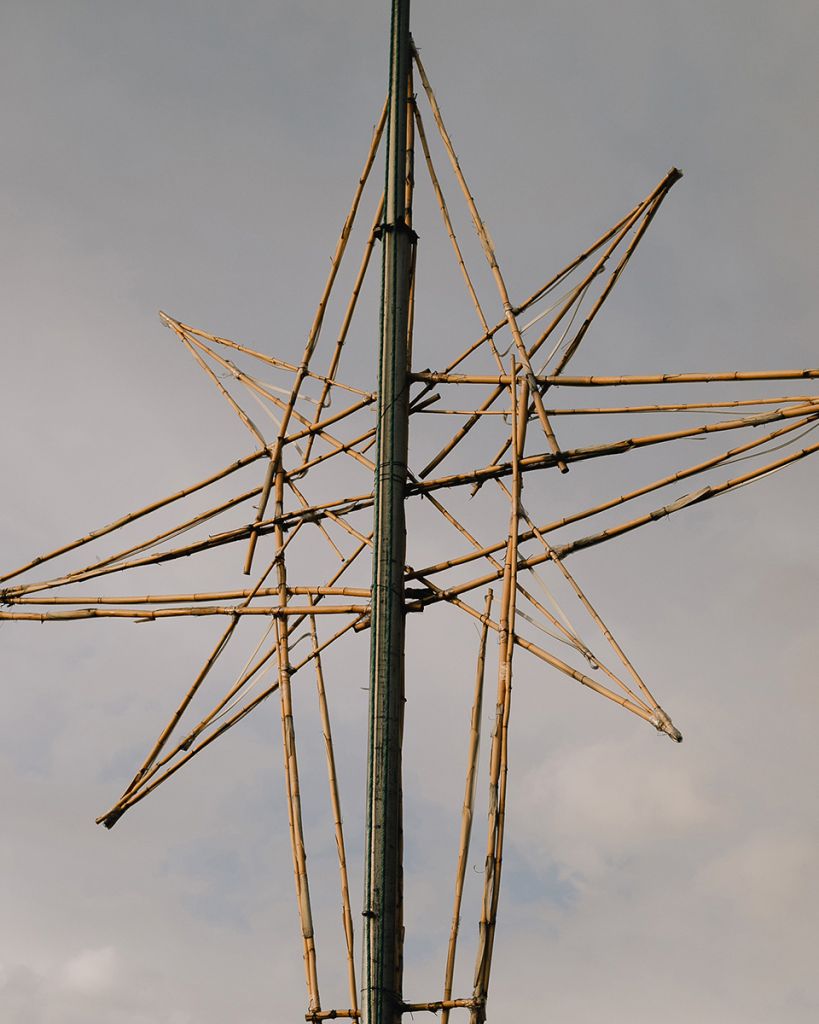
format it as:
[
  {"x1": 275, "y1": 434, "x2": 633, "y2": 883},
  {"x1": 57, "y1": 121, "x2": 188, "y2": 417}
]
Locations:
[{"x1": 0, "y1": 6, "x2": 819, "y2": 1024}]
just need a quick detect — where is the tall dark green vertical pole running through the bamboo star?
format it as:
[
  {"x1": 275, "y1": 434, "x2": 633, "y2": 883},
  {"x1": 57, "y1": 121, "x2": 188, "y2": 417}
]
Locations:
[{"x1": 361, "y1": 0, "x2": 414, "y2": 1024}]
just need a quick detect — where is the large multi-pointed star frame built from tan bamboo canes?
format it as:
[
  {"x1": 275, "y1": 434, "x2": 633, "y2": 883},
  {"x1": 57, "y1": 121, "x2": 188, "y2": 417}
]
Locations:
[{"x1": 0, "y1": 41, "x2": 819, "y2": 1024}]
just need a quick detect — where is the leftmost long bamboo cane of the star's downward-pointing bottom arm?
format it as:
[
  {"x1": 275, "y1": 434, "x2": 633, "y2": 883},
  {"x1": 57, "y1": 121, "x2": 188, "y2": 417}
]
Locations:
[{"x1": 273, "y1": 462, "x2": 321, "y2": 1011}]
